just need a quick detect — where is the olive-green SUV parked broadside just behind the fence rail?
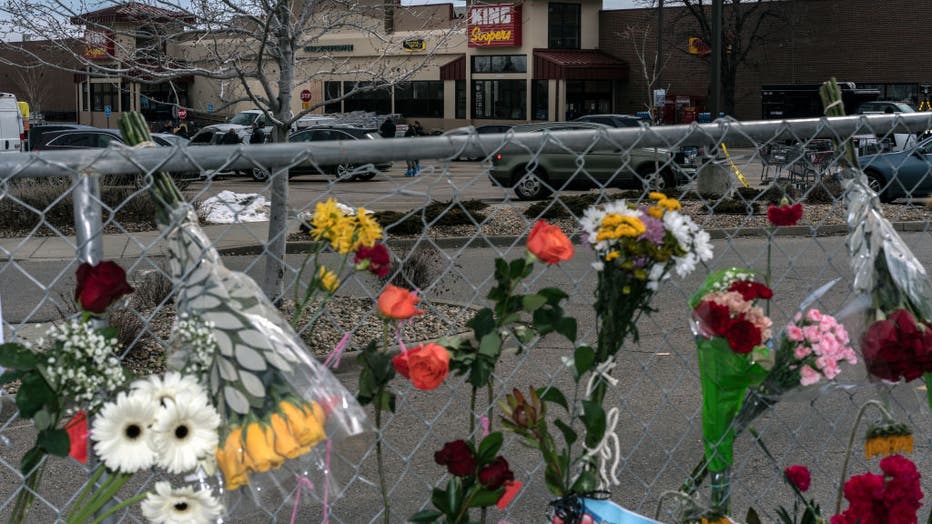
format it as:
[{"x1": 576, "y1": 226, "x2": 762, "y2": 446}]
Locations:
[{"x1": 489, "y1": 122, "x2": 687, "y2": 200}]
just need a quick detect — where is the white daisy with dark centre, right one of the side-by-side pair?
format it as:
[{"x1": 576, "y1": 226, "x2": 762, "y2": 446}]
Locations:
[{"x1": 152, "y1": 393, "x2": 220, "y2": 474}]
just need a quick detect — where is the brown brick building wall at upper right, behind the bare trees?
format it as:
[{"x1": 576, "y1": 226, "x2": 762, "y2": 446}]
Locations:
[{"x1": 599, "y1": 0, "x2": 932, "y2": 119}]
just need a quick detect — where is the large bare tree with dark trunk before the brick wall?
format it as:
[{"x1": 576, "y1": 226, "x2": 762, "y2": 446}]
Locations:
[{"x1": 640, "y1": 0, "x2": 789, "y2": 114}]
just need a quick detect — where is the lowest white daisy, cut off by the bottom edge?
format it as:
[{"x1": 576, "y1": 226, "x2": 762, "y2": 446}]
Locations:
[{"x1": 141, "y1": 481, "x2": 223, "y2": 524}]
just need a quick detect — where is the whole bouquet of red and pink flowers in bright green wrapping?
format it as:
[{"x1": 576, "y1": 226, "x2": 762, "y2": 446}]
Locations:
[{"x1": 689, "y1": 269, "x2": 774, "y2": 515}]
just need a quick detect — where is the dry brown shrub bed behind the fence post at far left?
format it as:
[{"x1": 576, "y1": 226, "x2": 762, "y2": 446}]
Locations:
[{"x1": 0, "y1": 178, "x2": 156, "y2": 231}]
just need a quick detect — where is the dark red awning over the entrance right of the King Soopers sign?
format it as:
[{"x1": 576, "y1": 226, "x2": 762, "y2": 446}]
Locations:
[{"x1": 534, "y1": 49, "x2": 628, "y2": 80}]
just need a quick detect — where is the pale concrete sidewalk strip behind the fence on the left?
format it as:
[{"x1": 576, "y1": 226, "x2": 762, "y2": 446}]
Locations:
[{"x1": 0, "y1": 220, "x2": 299, "y2": 261}]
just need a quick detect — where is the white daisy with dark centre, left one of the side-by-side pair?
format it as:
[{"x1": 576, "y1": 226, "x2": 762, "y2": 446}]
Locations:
[{"x1": 91, "y1": 392, "x2": 158, "y2": 473}]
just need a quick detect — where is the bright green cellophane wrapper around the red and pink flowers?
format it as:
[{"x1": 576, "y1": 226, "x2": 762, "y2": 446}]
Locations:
[{"x1": 689, "y1": 269, "x2": 768, "y2": 473}]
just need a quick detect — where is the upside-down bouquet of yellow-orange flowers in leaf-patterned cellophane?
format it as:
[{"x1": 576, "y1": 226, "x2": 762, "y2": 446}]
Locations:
[{"x1": 156, "y1": 205, "x2": 371, "y2": 515}]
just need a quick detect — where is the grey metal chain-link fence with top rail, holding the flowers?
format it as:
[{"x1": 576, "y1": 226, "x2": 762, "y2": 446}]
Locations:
[{"x1": 0, "y1": 113, "x2": 932, "y2": 523}]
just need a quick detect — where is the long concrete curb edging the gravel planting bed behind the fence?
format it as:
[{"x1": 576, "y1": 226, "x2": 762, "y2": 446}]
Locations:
[{"x1": 217, "y1": 221, "x2": 932, "y2": 256}]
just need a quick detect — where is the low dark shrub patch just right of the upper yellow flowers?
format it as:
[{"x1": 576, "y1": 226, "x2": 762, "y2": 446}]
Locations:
[{"x1": 372, "y1": 200, "x2": 489, "y2": 235}]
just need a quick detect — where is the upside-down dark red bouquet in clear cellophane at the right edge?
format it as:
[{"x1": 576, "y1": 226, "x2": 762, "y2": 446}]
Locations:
[{"x1": 845, "y1": 170, "x2": 932, "y2": 408}]
